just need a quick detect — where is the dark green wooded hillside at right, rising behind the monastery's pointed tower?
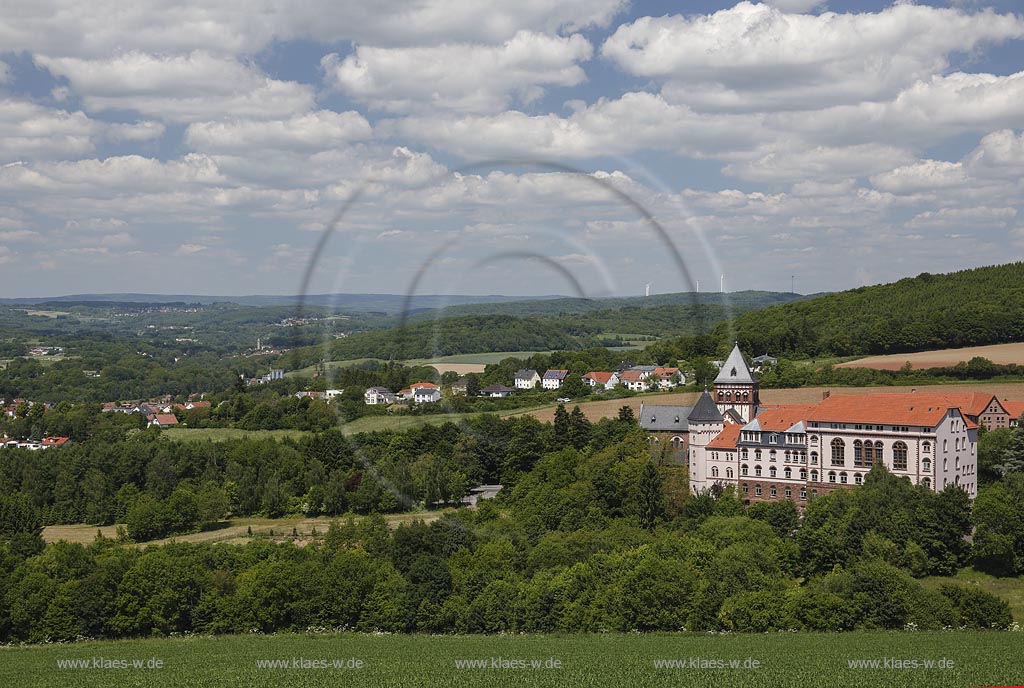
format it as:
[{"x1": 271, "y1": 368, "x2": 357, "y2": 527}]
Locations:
[{"x1": 715, "y1": 263, "x2": 1024, "y2": 355}]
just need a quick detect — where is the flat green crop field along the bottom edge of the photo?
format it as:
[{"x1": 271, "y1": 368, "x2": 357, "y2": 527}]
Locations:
[{"x1": 0, "y1": 632, "x2": 1024, "y2": 688}]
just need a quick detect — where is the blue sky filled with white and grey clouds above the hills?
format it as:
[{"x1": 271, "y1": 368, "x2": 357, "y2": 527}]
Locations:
[{"x1": 0, "y1": 0, "x2": 1024, "y2": 296}]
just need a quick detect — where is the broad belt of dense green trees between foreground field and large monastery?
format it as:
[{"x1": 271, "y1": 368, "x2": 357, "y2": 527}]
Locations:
[{"x1": 0, "y1": 414, "x2": 1024, "y2": 642}]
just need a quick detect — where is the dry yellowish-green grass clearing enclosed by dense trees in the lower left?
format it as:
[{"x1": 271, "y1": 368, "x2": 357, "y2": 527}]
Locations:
[{"x1": 43, "y1": 509, "x2": 452, "y2": 548}]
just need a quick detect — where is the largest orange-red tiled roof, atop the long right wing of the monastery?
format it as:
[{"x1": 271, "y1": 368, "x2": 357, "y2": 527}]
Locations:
[{"x1": 806, "y1": 392, "x2": 959, "y2": 427}]
